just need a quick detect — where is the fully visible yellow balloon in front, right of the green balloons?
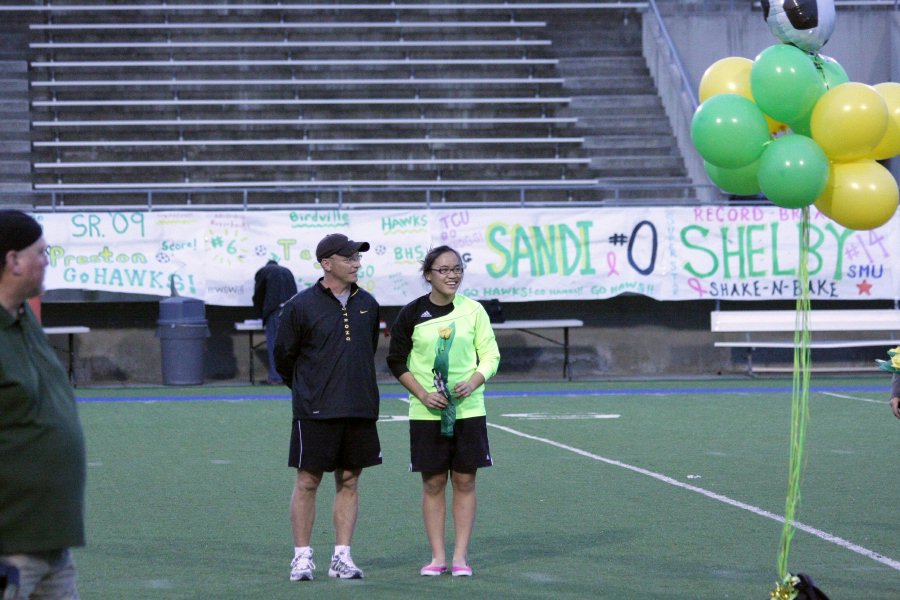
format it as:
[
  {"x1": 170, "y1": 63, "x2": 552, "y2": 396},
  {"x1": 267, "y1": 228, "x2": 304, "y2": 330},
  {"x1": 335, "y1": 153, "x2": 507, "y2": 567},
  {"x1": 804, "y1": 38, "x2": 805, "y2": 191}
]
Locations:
[{"x1": 810, "y1": 81, "x2": 888, "y2": 162}]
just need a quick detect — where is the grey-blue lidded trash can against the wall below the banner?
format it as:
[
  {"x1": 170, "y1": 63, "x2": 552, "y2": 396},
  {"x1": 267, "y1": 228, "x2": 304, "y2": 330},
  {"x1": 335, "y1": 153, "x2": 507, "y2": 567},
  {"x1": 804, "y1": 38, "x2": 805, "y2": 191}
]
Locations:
[{"x1": 156, "y1": 296, "x2": 209, "y2": 385}]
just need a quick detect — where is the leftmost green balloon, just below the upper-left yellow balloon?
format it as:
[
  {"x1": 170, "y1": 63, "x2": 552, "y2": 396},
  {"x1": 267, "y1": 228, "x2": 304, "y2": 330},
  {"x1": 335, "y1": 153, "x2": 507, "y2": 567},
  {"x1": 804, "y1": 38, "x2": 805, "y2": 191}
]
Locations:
[{"x1": 691, "y1": 94, "x2": 769, "y2": 169}]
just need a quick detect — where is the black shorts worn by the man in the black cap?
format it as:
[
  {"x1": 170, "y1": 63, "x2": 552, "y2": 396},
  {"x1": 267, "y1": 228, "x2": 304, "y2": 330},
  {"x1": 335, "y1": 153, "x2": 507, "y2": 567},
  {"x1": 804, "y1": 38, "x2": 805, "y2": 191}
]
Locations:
[{"x1": 288, "y1": 419, "x2": 381, "y2": 472}]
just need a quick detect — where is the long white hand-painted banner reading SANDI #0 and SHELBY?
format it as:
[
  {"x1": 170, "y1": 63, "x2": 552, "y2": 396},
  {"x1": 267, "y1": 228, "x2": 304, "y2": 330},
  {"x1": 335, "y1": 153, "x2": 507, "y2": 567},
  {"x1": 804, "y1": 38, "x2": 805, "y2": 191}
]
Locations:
[{"x1": 35, "y1": 206, "x2": 900, "y2": 306}]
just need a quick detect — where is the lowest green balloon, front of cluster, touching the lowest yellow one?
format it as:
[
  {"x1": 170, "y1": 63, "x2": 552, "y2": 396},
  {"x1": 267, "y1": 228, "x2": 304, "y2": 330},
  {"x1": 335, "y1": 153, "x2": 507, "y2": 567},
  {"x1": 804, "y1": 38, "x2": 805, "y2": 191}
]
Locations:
[{"x1": 758, "y1": 135, "x2": 829, "y2": 208}]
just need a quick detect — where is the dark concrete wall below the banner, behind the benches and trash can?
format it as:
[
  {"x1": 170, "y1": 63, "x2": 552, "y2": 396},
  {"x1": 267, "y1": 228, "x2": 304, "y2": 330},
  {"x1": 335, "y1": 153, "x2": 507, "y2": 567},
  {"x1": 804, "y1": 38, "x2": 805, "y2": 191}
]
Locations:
[{"x1": 43, "y1": 295, "x2": 893, "y2": 386}]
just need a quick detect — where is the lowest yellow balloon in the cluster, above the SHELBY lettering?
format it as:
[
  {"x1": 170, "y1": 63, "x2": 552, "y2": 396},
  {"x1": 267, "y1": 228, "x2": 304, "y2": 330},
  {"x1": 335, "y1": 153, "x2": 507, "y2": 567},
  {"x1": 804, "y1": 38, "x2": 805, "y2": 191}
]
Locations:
[{"x1": 816, "y1": 160, "x2": 900, "y2": 229}]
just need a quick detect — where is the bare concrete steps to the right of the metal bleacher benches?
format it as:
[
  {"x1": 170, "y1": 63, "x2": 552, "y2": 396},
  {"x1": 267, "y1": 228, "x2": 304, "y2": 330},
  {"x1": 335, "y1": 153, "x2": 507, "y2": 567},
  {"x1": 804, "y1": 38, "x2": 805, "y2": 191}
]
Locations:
[{"x1": 547, "y1": 10, "x2": 690, "y2": 200}]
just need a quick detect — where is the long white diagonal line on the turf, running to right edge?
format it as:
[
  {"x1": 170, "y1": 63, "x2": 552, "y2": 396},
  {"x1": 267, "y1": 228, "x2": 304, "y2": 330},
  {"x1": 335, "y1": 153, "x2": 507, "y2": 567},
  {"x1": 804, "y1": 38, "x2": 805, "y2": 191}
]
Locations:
[{"x1": 488, "y1": 423, "x2": 900, "y2": 571}]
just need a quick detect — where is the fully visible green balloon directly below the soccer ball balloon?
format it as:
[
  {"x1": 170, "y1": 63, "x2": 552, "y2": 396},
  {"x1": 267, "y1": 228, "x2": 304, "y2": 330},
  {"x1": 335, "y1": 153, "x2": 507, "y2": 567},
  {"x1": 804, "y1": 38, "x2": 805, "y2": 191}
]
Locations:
[{"x1": 750, "y1": 44, "x2": 826, "y2": 123}]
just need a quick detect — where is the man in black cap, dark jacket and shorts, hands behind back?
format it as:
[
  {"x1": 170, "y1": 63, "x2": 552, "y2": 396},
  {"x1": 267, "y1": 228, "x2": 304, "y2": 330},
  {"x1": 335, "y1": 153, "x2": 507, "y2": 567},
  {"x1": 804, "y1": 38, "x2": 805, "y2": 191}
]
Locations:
[{"x1": 274, "y1": 234, "x2": 381, "y2": 581}]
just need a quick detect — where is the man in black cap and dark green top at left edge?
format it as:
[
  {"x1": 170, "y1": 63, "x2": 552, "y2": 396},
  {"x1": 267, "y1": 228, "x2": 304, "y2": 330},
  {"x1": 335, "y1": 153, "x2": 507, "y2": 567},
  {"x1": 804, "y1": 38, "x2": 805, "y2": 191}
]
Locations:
[{"x1": 0, "y1": 210, "x2": 86, "y2": 600}]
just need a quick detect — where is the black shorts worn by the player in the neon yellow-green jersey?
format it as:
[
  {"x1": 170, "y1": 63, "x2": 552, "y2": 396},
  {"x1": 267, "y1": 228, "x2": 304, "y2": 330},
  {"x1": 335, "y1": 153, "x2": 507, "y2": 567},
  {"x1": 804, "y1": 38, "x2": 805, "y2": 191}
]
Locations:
[{"x1": 409, "y1": 417, "x2": 494, "y2": 473}]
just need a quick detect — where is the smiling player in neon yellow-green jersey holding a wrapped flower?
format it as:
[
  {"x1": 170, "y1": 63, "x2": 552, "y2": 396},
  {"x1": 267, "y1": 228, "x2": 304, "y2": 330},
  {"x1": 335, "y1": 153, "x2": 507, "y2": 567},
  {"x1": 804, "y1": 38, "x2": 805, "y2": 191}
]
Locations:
[{"x1": 387, "y1": 246, "x2": 500, "y2": 576}]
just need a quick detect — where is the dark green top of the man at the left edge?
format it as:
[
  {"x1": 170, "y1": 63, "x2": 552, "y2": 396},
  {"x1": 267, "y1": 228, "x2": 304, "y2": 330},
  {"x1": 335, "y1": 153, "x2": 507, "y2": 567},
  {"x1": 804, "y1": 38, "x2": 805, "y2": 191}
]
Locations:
[{"x1": 0, "y1": 305, "x2": 85, "y2": 554}]
